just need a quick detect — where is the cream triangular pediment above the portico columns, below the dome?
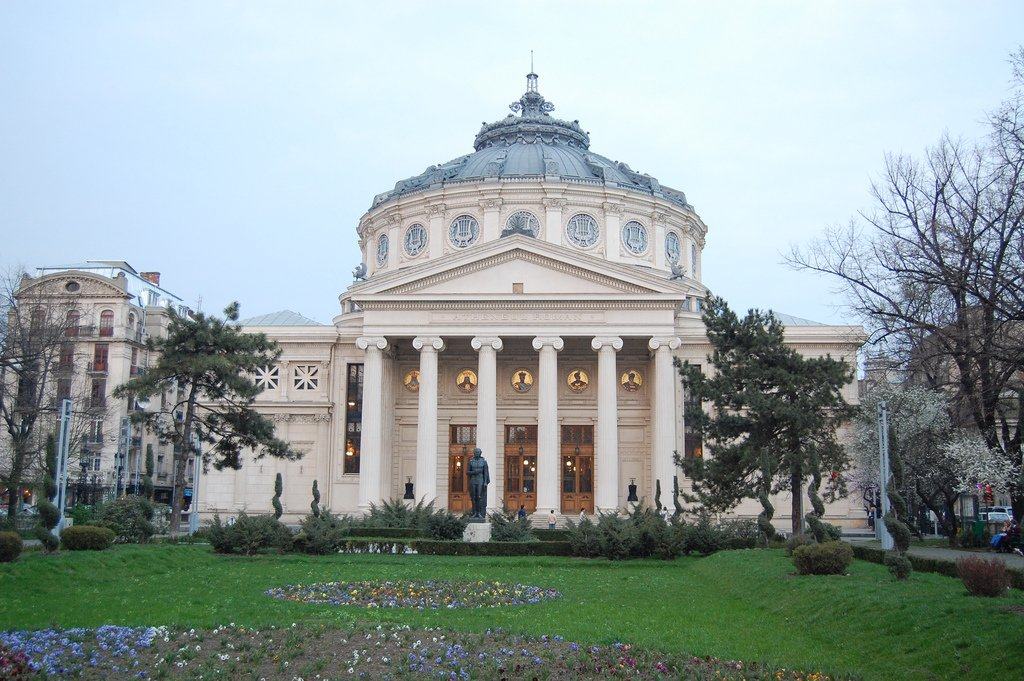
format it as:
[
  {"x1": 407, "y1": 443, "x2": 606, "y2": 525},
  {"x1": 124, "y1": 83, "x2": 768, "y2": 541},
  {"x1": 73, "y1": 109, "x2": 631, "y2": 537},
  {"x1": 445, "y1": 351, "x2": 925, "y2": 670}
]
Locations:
[{"x1": 352, "y1": 237, "x2": 688, "y2": 299}]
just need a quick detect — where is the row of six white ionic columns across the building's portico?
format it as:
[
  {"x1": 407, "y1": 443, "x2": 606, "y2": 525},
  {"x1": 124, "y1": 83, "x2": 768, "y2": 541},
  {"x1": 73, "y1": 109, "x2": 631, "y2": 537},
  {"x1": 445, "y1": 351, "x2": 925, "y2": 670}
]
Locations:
[{"x1": 356, "y1": 336, "x2": 680, "y2": 514}]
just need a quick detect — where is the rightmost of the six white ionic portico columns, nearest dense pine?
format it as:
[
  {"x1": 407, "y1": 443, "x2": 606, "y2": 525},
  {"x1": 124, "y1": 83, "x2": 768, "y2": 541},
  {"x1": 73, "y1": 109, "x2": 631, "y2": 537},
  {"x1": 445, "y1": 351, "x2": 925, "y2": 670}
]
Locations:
[{"x1": 647, "y1": 336, "x2": 681, "y2": 507}]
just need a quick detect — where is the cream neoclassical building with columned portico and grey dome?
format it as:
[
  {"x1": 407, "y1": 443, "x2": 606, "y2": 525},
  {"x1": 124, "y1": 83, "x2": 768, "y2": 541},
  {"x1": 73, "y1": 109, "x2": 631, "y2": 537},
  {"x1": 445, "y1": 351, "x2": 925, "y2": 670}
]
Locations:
[{"x1": 199, "y1": 74, "x2": 863, "y2": 526}]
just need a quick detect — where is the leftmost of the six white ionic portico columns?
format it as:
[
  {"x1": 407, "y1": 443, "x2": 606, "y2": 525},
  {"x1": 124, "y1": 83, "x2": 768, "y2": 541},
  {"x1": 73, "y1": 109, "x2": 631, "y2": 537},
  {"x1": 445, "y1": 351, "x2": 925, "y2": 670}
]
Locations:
[{"x1": 355, "y1": 336, "x2": 387, "y2": 511}]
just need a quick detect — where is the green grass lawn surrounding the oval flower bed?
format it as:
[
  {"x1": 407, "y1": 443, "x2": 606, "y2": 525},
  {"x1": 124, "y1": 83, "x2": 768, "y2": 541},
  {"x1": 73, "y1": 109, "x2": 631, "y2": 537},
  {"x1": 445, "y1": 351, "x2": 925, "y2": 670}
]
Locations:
[{"x1": 0, "y1": 545, "x2": 1024, "y2": 679}]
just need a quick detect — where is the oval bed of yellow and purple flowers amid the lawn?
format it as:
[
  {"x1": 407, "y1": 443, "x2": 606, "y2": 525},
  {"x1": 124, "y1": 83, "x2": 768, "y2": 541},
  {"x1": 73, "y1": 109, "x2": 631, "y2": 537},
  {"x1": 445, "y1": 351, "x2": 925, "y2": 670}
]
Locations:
[{"x1": 266, "y1": 580, "x2": 561, "y2": 610}]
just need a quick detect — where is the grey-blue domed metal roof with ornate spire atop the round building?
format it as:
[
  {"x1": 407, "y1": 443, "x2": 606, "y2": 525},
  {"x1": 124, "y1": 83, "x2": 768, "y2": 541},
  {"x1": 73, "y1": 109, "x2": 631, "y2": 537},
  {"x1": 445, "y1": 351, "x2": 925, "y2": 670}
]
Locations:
[{"x1": 372, "y1": 73, "x2": 692, "y2": 209}]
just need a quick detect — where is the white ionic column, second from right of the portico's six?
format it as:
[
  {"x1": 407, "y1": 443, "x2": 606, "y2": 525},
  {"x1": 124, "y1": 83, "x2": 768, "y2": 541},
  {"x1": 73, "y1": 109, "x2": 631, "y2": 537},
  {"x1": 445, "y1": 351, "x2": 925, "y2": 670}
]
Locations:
[{"x1": 590, "y1": 336, "x2": 623, "y2": 512}]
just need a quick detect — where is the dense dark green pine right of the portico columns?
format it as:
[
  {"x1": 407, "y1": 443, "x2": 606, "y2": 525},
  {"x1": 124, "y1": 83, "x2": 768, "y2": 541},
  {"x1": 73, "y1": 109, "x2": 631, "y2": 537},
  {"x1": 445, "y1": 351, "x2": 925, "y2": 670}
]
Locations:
[{"x1": 676, "y1": 296, "x2": 853, "y2": 539}]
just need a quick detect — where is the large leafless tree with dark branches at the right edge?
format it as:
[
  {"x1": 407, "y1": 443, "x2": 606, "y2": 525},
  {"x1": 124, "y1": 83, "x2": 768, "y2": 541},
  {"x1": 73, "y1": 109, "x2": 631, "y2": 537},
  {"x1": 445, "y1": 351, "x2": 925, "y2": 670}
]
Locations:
[{"x1": 790, "y1": 50, "x2": 1024, "y2": 517}]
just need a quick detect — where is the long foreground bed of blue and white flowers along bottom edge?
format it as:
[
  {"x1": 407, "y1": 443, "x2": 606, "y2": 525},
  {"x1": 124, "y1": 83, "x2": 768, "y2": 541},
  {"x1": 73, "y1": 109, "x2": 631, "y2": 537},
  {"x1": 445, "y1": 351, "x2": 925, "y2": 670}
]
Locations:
[{"x1": 3, "y1": 625, "x2": 830, "y2": 681}]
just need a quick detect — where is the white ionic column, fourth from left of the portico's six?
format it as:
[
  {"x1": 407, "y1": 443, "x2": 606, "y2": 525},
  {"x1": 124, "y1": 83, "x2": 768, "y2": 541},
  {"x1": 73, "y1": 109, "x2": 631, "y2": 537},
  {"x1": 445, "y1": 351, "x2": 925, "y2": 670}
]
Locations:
[{"x1": 534, "y1": 336, "x2": 565, "y2": 515}]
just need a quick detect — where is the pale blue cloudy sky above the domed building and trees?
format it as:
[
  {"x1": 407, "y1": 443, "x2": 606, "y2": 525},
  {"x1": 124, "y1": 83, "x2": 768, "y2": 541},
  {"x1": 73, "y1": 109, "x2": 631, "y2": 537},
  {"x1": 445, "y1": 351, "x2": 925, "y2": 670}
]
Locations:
[{"x1": 0, "y1": 0, "x2": 1024, "y2": 324}]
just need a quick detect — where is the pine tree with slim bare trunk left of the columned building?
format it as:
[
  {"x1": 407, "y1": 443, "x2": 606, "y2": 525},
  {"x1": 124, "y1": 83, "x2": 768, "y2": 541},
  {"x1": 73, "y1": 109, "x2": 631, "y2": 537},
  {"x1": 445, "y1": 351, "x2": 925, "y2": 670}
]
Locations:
[{"x1": 114, "y1": 303, "x2": 301, "y2": 535}]
